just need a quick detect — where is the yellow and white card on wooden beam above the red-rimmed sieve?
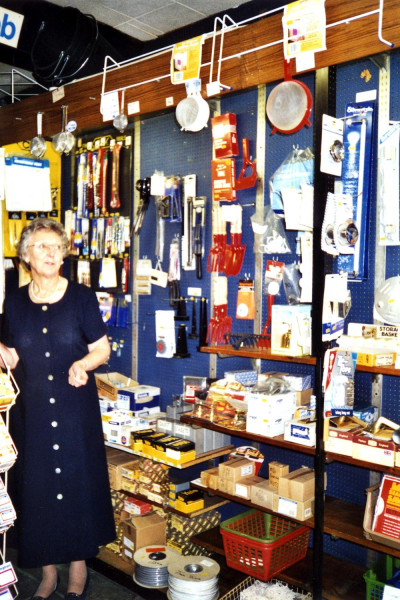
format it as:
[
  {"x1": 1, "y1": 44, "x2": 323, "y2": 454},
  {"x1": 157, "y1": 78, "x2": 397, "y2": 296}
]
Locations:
[{"x1": 282, "y1": 0, "x2": 326, "y2": 60}]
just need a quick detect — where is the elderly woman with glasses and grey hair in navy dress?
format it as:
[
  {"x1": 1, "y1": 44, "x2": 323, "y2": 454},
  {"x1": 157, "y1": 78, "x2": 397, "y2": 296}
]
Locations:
[{"x1": 0, "y1": 219, "x2": 115, "y2": 600}]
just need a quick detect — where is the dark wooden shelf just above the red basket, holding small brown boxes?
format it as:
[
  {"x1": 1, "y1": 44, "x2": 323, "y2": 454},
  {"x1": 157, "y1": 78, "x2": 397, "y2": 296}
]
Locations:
[{"x1": 192, "y1": 482, "x2": 400, "y2": 558}]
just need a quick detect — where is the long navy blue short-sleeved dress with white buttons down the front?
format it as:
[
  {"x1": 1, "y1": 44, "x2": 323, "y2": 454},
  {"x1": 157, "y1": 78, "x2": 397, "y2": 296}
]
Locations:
[{"x1": 2, "y1": 282, "x2": 116, "y2": 568}]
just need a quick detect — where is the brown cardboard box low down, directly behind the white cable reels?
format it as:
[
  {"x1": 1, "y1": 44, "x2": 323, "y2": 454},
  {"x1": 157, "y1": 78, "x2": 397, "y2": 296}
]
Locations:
[{"x1": 122, "y1": 513, "x2": 167, "y2": 563}]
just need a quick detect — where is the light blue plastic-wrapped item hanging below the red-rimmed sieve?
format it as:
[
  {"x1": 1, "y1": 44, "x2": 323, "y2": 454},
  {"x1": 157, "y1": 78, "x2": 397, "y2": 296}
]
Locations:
[{"x1": 269, "y1": 146, "x2": 314, "y2": 215}]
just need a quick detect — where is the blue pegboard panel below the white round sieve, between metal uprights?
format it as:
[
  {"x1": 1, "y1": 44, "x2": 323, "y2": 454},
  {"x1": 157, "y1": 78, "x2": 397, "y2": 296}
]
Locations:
[{"x1": 136, "y1": 113, "x2": 212, "y2": 409}]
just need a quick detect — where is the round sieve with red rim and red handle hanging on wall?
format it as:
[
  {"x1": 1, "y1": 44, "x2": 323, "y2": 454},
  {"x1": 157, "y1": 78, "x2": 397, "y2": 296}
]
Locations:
[{"x1": 267, "y1": 60, "x2": 312, "y2": 133}]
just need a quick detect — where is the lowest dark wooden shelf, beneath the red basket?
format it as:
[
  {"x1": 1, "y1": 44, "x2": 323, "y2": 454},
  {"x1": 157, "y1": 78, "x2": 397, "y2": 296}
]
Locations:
[{"x1": 191, "y1": 527, "x2": 367, "y2": 600}]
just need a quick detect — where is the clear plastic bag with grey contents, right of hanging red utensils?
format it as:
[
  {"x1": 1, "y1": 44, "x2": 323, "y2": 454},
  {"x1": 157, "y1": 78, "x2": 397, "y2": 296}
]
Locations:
[{"x1": 250, "y1": 206, "x2": 291, "y2": 254}]
